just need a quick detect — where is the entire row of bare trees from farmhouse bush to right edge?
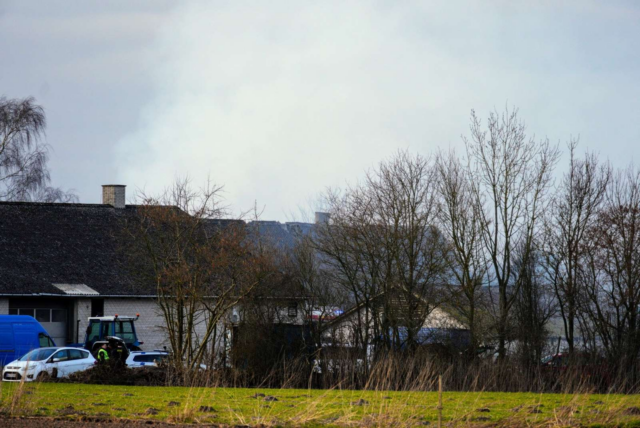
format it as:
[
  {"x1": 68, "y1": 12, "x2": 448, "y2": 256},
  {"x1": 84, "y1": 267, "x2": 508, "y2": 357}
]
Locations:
[{"x1": 128, "y1": 110, "x2": 640, "y2": 390}]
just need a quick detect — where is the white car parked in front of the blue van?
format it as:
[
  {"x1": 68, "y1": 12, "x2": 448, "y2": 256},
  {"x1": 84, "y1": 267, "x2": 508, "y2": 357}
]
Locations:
[{"x1": 2, "y1": 348, "x2": 97, "y2": 382}]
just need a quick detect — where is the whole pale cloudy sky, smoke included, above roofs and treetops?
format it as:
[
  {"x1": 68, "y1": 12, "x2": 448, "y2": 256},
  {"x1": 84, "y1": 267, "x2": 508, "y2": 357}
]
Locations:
[{"x1": 0, "y1": 0, "x2": 640, "y2": 221}]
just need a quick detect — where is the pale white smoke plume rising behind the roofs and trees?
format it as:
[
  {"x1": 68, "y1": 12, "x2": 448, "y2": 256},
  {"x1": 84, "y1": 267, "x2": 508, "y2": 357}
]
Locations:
[{"x1": 117, "y1": 1, "x2": 640, "y2": 219}]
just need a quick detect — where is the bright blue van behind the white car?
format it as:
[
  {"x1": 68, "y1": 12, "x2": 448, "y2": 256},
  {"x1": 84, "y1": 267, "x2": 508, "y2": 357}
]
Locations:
[{"x1": 0, "y1": 315, "x2": 56, "y2": 366}]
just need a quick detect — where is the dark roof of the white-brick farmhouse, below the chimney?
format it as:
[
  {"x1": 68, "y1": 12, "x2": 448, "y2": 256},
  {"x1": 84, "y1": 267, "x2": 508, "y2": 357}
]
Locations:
[{"x1": 0, "y1": 202, "x2": 149, "y2": 296}]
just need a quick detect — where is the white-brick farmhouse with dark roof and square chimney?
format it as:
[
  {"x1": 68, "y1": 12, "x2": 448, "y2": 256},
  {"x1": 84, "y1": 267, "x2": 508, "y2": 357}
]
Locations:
[{"x1": 0, "y1": 185, "x2": 307, "y2": 349}]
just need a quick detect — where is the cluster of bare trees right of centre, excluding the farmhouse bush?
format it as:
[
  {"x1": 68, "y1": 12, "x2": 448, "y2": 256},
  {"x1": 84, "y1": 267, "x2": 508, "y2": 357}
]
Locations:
[{"x1": 310, "y1": 110, "x2": 640, "y2": 369}]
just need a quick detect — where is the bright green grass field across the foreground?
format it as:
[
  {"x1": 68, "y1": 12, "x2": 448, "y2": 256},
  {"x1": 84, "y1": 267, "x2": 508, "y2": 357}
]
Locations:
[{"x1": 0, "y1": 383, "x2": 640, "y2": 427}]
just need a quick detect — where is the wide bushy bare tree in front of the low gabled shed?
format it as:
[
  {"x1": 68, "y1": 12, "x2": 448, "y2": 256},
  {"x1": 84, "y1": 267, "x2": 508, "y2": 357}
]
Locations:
[{"x1": 317, "y1": 152, "x2": 447, "y2": 356}]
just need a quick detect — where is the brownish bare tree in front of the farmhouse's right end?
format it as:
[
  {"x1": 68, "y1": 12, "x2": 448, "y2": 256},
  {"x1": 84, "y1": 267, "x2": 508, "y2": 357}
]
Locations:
[{"x1": 125, "y1": 179, "x2": 261, "y2": 369}]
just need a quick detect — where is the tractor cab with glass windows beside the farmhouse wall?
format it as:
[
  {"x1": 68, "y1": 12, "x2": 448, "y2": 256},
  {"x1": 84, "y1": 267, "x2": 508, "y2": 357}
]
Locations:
[{"x1": 84, "y1": 314, "x2": 143, "y2": 351}]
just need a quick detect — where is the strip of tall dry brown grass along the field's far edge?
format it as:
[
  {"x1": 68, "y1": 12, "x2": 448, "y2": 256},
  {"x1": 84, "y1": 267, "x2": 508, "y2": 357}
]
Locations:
[{"x1": 196, "y1": 354, "x2": 640, "y2": 394}]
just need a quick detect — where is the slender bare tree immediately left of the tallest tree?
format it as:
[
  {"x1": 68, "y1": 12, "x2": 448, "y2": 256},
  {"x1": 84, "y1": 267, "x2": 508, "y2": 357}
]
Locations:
[{"x1": 436, "y1": 153, "x2": 489, "y2": 356}]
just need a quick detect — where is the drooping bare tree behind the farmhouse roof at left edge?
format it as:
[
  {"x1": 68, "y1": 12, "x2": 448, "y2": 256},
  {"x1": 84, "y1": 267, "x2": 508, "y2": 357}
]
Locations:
[{"x1": 0, "y1": 97, "x2": 77, "y2": 202}]
